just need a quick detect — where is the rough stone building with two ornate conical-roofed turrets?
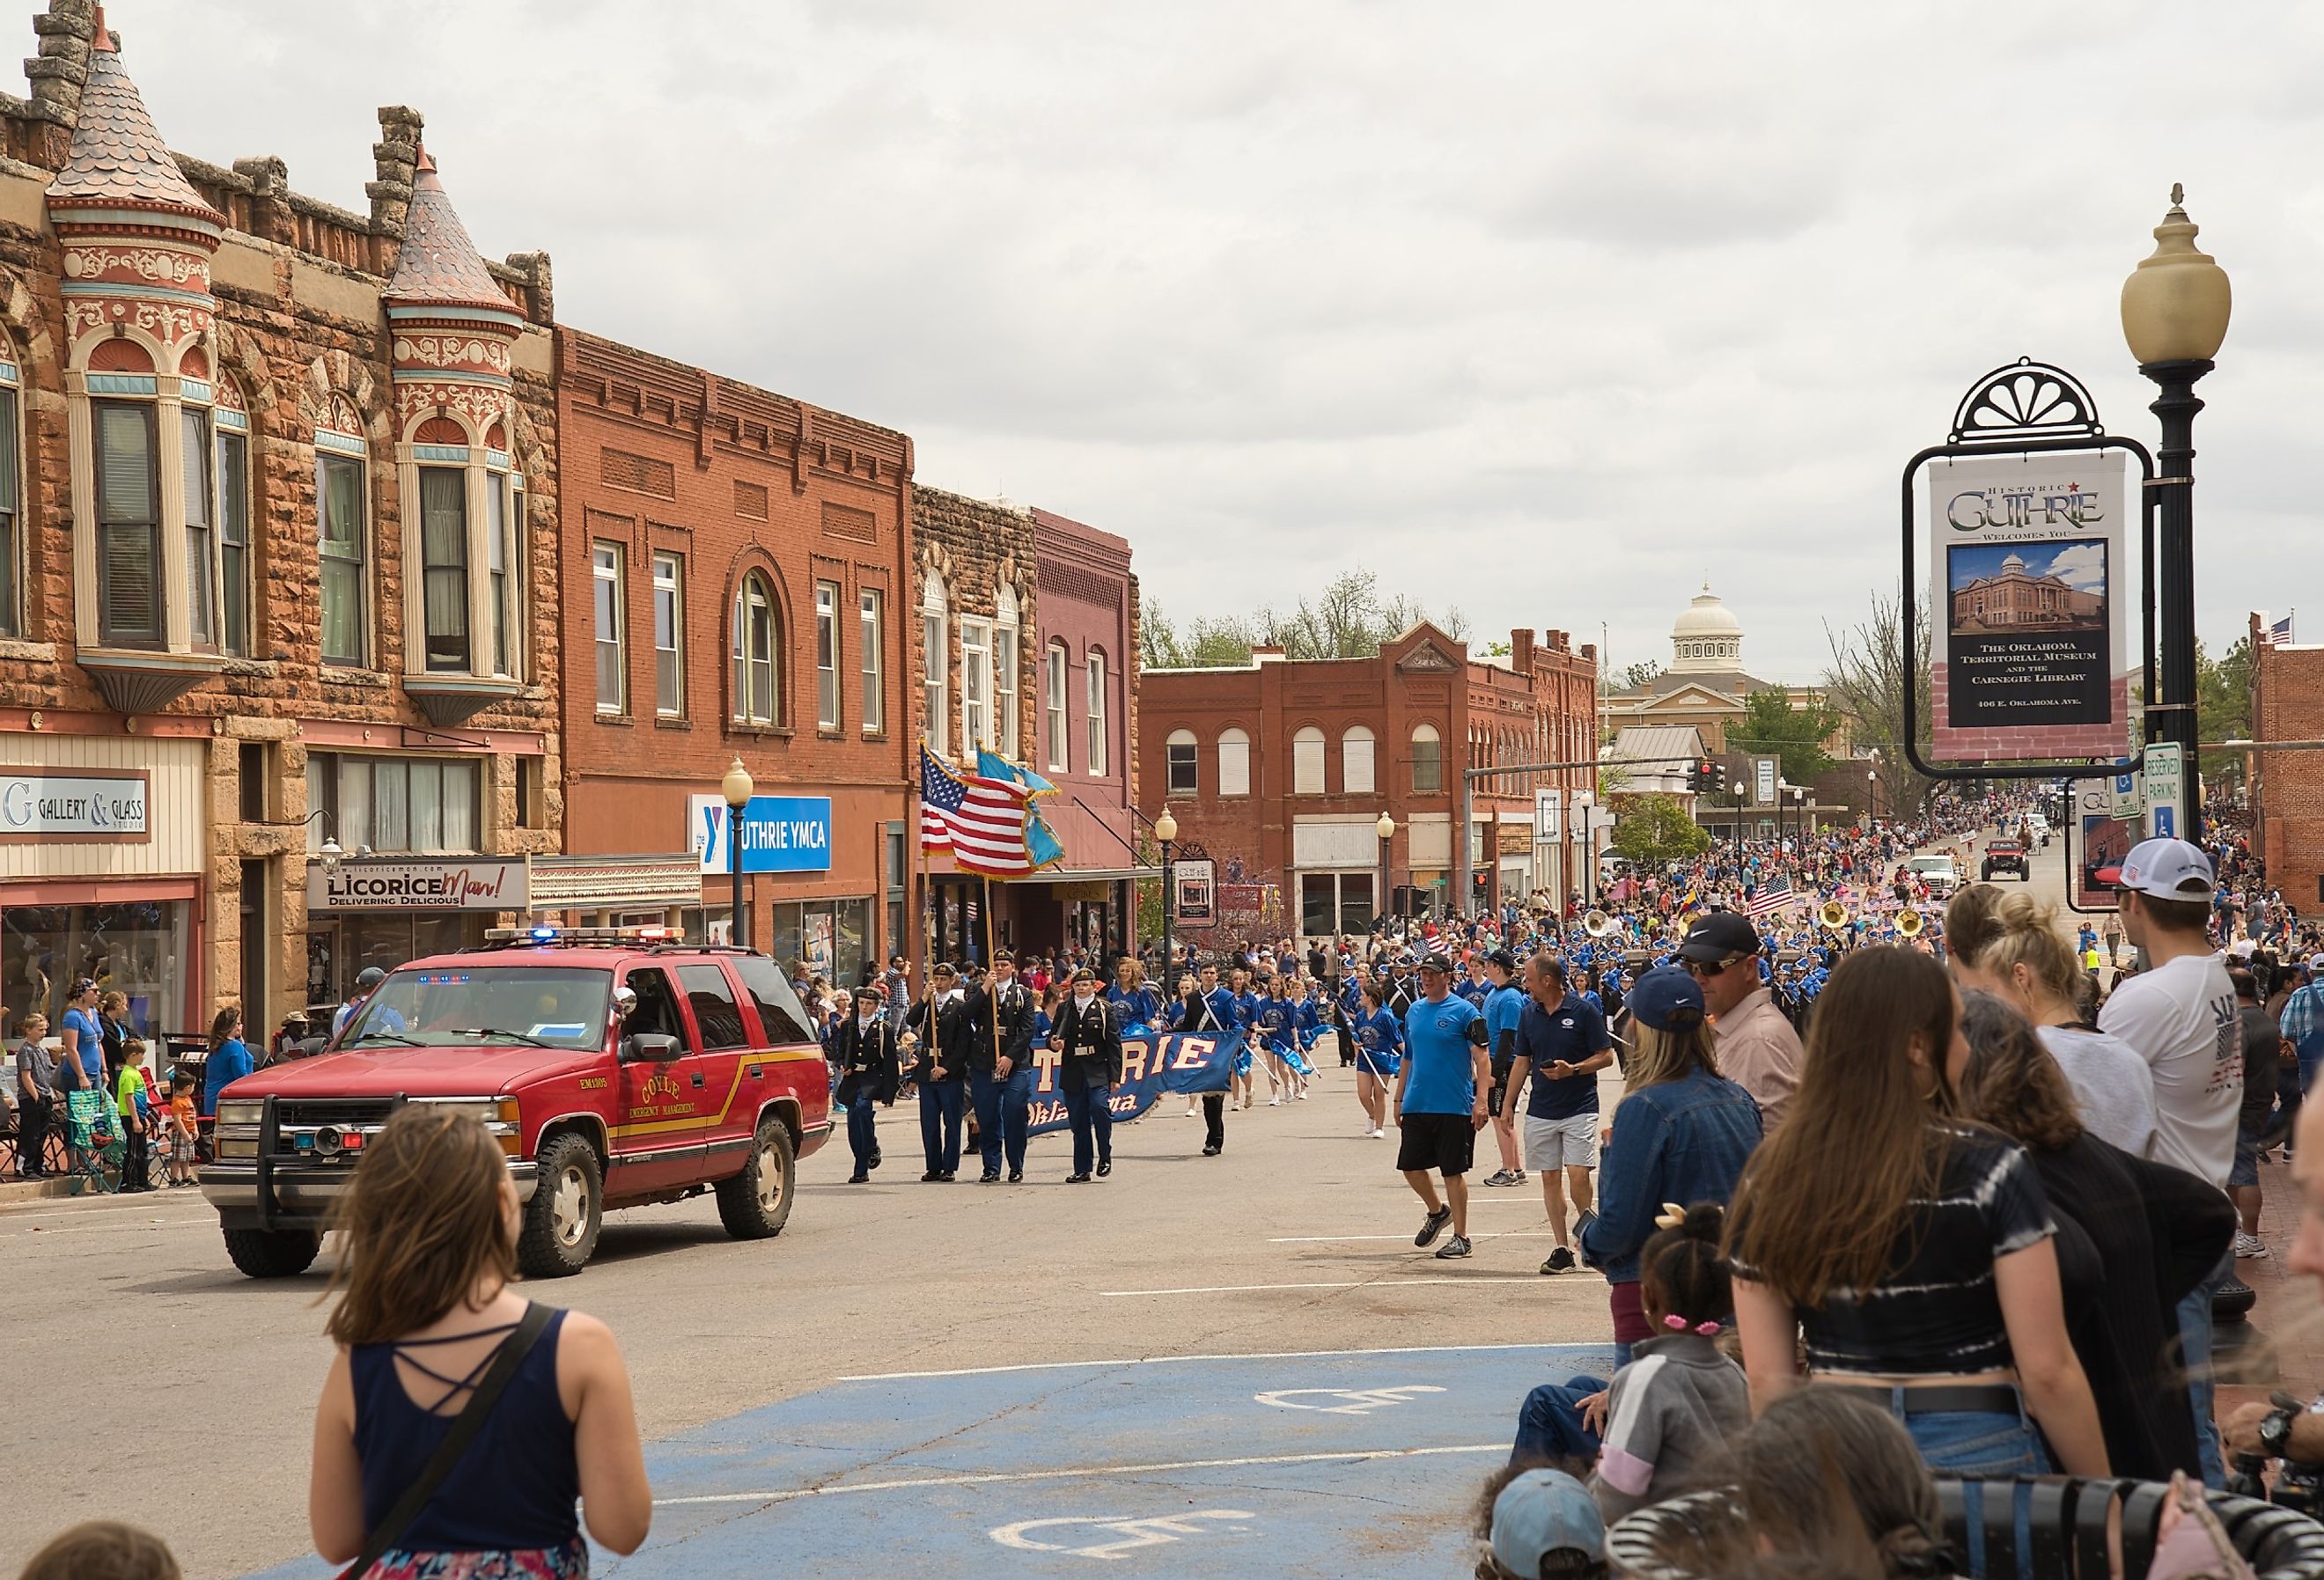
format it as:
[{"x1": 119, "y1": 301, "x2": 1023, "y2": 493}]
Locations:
[{"x1": 0, "y1": 0, "x2": 563, "y2": 1050}]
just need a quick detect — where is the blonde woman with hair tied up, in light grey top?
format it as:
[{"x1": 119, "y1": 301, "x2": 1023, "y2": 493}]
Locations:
[{"x1": 1954, "y1": 893, "x2": 2154, "y2": 1157}]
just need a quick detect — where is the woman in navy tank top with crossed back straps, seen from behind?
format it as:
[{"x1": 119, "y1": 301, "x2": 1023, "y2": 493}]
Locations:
[{"x1": 306, "y1": 1104, "x2": 653, "y2": 1580}]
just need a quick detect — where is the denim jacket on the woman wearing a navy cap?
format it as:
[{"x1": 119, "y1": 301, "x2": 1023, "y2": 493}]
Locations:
[{"x1": 1580, "y1": 1071, "x2": 1759, "y2": 1282}]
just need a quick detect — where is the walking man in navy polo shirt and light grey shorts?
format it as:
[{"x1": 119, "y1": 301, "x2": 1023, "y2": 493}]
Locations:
[{"x1": 1508, "y1": 955, "x2": 1613, "y2": 1274}]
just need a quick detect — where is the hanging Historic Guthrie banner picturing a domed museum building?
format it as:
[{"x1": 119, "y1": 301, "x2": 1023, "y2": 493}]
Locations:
[{"x1": 1929, "y1": 451, "x2": 2131, "y2": 762}]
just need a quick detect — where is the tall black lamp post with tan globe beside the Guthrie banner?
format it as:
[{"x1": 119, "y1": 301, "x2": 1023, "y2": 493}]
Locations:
[{"x1": 2122, "y1": 186, "x2": 2233, "y2": 843}]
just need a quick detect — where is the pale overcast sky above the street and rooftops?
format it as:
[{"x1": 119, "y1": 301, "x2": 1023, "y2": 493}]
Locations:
[{"x1": 122, "y1": 0, "x2": 2324, "y2": 680}]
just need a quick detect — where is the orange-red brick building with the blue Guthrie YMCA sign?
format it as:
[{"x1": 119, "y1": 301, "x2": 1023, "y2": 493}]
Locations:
[{"x1": 558, "y1": 327, "x2": 920, "y2": 983}]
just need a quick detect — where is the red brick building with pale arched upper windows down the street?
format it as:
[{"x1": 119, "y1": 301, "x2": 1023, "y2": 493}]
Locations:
[{"x1": 1139, "y1": 625, "x2": 1597, "y2": 934}]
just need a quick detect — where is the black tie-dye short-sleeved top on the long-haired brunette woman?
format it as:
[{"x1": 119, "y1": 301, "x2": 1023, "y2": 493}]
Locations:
[{"x1": 1733, "y1": 1125, "x2": 2056, "y2": 1378}]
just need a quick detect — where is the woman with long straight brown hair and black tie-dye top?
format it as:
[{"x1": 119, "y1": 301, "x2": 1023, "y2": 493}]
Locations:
[{"x1": 1727, "y1": 948, "x2": 2107, "y2": 1475}]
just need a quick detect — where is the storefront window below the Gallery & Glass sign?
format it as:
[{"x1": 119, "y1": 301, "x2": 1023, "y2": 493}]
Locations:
[{"x1": 0, "y1": 900, "x2": 189, "y2": 1036}]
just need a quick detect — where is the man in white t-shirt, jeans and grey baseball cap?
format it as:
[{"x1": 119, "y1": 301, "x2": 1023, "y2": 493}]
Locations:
[{"x1": 2099, "y1": 839, "x2": 2243, "y2": 1487}]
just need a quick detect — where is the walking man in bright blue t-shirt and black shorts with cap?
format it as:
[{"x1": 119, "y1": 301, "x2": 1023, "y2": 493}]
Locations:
[{"x1": 1397, "y1": 955, "x2": 1492, "y2": 1260}]
